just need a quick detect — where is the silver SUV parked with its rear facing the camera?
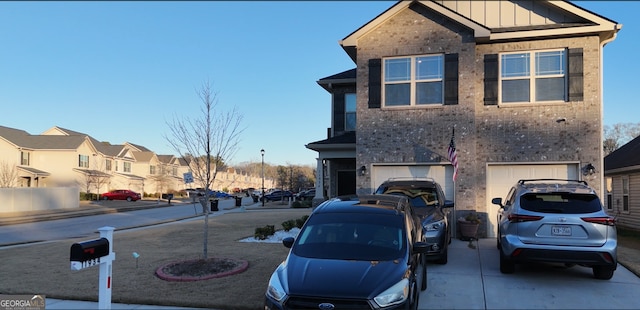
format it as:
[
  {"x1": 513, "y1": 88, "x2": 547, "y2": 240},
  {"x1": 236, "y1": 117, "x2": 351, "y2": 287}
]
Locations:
[{"x1": 491, "y1": 179, "x2": 618, "y2": 280}]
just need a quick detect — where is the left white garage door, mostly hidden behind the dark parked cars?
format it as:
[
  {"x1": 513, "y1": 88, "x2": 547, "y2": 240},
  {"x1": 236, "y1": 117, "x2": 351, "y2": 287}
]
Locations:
[{"x1": 371, "y1": 165, "x2": 454, "y2": 201}]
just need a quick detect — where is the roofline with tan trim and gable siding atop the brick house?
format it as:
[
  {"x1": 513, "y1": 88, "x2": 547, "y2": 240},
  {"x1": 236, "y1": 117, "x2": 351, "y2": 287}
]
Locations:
[{"x1": 339, "y1": 0, "x2": 622, "y2": 62}]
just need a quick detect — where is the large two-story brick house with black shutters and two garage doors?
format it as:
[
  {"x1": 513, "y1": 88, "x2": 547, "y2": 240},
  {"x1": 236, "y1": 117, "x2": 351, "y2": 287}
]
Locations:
[{"x1": 306, "y1": 0, "x2": 621, "y2": 237}]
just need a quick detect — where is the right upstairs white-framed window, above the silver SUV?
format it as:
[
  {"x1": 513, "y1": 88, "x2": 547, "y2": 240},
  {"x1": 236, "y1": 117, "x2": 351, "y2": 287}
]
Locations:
[{"x1": 500, "y1": 49, "x2": 568, "y2": 103}]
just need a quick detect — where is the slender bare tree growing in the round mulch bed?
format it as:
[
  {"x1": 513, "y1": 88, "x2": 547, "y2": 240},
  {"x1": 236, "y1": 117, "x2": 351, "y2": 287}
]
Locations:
[{"x1": 164, "y1": 81, "x2": 244, "y2": 259}]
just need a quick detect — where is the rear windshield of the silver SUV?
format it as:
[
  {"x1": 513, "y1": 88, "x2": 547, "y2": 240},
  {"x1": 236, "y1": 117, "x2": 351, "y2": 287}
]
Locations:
[{"x1": 520, "y1": 193, "x2": 602, "y2": 214}]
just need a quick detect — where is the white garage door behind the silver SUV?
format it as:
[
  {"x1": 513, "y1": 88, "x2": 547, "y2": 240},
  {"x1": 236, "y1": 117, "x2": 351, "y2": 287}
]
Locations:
[{"x1": 486, "y1": 164, "x2": 579, "y2": 237}]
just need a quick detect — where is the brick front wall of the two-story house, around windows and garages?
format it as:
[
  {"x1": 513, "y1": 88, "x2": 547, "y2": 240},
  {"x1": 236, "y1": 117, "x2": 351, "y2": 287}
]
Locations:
[{"x1": 356, "y1": 5, "x2": 602, "y2": 223}]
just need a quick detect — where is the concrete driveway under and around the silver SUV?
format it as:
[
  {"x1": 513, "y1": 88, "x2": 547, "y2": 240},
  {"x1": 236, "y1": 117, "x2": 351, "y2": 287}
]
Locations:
[{"x1": 419, "y1": 238, "x2": 640, "y2": 309}]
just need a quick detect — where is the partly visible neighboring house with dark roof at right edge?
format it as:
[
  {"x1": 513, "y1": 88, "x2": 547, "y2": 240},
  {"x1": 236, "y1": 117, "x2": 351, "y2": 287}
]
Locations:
[{"x1": 604, "y1": 137, "x2": 640, "y2": 229}]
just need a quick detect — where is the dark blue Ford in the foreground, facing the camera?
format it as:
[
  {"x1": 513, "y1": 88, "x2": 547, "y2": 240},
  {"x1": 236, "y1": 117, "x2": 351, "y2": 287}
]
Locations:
[{"x1": 265, "y1": 195, "x2": 428, "y2": 309}]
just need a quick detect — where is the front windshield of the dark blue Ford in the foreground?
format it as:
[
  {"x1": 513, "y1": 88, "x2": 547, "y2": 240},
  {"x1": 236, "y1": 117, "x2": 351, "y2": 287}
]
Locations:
[{"x1": 293, "y1": 213, "x2": 407, "y2": 261}]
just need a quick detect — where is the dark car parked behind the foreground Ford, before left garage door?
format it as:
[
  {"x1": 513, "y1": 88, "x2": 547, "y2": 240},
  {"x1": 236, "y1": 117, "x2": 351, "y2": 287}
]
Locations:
[{"x1": 376, "y1": 178, "x2": 453, "y2": 264}]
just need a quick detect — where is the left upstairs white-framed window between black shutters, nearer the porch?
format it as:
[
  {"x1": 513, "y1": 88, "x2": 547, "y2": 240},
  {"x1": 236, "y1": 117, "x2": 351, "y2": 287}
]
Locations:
[{"x1": 383, "y1": 54, "x2": 444, "y2": 107}]
